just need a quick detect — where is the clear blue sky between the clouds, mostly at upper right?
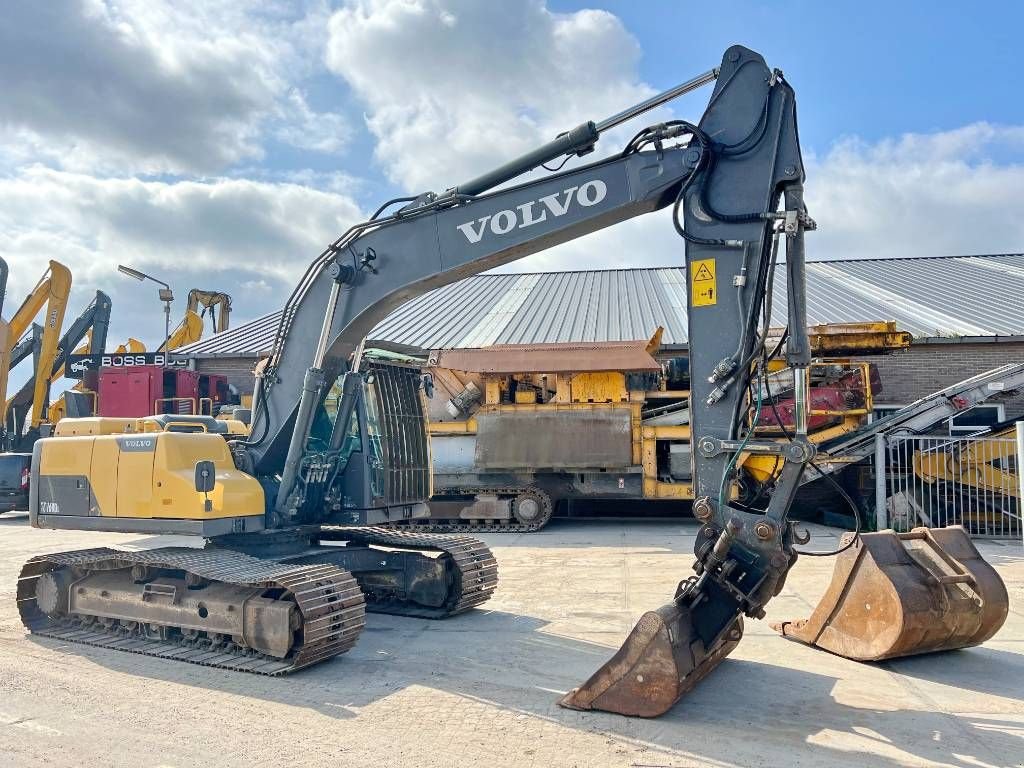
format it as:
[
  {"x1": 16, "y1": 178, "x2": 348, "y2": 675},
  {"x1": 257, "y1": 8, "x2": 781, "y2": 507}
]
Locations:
[{"x1": 278, "y1": 0, "x2": 1024, "y2": 201}]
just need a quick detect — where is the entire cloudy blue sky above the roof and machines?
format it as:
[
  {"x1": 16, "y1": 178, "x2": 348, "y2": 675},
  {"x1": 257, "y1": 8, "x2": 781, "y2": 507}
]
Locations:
[{"x1": 0, "y1": 0, "x2": 1024, "y2": 364}]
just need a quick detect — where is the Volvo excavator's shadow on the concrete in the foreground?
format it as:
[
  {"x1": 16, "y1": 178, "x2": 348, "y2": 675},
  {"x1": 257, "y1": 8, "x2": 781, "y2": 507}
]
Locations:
[{"x1": 24, "y1": 609, "x2": 1021, "y2": 768}]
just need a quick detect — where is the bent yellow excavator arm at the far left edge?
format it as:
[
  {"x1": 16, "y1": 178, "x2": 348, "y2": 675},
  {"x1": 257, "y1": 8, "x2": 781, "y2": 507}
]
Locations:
[{"x1": 0, "y1": 261, "x2": 72, "y2": 428}]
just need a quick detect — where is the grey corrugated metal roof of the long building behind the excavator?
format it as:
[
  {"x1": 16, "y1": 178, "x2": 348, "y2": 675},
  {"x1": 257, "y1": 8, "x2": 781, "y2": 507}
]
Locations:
[{"x1": 178, "y1": 254, "x2": 1024, "y2": 356}]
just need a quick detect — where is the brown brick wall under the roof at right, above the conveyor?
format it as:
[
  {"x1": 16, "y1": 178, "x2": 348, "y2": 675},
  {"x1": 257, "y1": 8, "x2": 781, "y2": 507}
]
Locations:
[{"x1": 865, "y1": 341, "x2": 1024, "y2": 419}]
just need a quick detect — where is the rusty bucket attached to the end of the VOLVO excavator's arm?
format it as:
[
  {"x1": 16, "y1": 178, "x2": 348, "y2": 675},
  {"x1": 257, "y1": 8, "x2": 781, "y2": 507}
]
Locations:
[{"x1": 558, "y1": 603, "x2": 743, "y2": 718}]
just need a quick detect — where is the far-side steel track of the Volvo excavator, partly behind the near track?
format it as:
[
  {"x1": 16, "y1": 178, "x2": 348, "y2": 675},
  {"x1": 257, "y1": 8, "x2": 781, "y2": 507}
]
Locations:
[{"x1": 318, "y1": 525, "x2": 498, "y2": 618}]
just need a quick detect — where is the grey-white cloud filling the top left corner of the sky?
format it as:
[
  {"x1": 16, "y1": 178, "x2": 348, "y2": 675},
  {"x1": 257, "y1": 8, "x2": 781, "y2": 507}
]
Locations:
[{"x1": 0, "y1": 0, "x2": 349, "y2": 175}]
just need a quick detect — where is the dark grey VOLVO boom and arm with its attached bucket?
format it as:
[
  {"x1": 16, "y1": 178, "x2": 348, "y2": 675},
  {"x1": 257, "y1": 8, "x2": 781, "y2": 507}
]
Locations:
[{"x1": 246, "y1": 46, "x2": 812, "y2": 696}]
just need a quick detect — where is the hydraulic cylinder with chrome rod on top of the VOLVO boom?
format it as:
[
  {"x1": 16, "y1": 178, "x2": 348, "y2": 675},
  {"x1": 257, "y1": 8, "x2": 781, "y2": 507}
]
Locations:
[{"x1": 452, "y1": 68, "x2": 718, "y2": 197}]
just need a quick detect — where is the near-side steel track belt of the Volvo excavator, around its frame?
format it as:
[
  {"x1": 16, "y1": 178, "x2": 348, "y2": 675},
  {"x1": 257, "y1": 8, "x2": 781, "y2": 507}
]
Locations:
[{"x1": 17, "y1": 548, "x2": 365, "y2": 675}]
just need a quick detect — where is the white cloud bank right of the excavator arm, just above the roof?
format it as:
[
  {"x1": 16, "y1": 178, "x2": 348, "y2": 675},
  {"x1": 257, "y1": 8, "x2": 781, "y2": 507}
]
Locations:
[{"x1": 806, "y1": 123, "x2": 1024, "y2": 259}]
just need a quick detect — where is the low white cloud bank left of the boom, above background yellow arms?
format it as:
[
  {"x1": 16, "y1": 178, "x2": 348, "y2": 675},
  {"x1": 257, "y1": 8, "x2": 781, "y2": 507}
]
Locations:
[{"x1": 0, "y1": 166, "x2": 364, "y2": 344}]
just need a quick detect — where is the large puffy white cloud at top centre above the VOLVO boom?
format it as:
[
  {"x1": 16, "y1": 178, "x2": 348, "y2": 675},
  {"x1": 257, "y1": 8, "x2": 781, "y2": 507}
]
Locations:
[{"x1": 327, "y1": 0, "x2": 652, "y2": 191}]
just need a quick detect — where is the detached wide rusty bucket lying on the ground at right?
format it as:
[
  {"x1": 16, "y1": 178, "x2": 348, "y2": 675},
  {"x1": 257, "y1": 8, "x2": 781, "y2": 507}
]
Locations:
[{"x1": 772, "y1": 525, "x2": 1010, "y2": 662}]
